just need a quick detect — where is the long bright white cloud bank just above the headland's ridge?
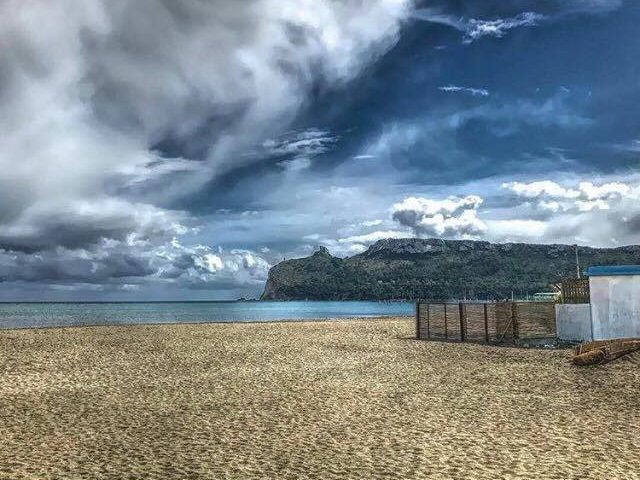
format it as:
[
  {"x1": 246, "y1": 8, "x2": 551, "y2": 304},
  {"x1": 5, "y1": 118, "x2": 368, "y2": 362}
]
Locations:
[{"x1": 294, "y1": 174, "x2": 640, "y2": 256}]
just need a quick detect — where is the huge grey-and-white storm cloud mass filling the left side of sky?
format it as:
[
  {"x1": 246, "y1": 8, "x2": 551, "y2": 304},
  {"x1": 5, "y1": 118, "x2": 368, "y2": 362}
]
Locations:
[{"x1": 0, "y1": 0, "x2": 410, "y2": 296}]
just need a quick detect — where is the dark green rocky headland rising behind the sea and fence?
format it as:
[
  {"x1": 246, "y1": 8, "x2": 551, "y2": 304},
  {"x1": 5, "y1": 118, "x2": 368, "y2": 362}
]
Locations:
[{"x1": 262, "y1": 239, "x2": 640, "y2": 300}]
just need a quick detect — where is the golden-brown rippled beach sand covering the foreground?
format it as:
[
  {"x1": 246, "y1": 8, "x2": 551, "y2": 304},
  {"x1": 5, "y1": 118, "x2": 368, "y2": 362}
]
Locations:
[{"x1": 0, "y1": 319, "x2": 640, "y2": 480}]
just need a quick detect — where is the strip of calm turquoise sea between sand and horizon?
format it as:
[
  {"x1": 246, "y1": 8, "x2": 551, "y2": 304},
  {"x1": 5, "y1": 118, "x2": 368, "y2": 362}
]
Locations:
[{"x1": 0, "y1": 302, "x2": 414, "y2": 328}]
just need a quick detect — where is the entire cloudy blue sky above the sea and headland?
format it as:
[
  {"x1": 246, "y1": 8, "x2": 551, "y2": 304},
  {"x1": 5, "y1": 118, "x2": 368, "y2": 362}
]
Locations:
[{"x1": 0, "y1": 0, "x2": 640, "y2": 301}]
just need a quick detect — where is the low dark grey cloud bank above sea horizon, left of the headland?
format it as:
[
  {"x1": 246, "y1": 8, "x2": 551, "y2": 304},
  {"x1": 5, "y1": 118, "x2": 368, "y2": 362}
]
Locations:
[{"x1": 0, "y1": 236, "x2": 269, "y2": 288}]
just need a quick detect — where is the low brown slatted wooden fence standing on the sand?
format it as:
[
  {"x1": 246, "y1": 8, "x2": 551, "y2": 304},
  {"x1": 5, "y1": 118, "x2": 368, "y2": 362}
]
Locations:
[{"x1": 416, "y1": 301, "x2": 556, "y2": 344}]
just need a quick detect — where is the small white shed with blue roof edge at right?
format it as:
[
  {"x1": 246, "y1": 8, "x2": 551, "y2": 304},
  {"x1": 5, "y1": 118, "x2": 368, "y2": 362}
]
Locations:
[{"x1": 587, "y1": 265, "x2": 640, "y2": 340}]
